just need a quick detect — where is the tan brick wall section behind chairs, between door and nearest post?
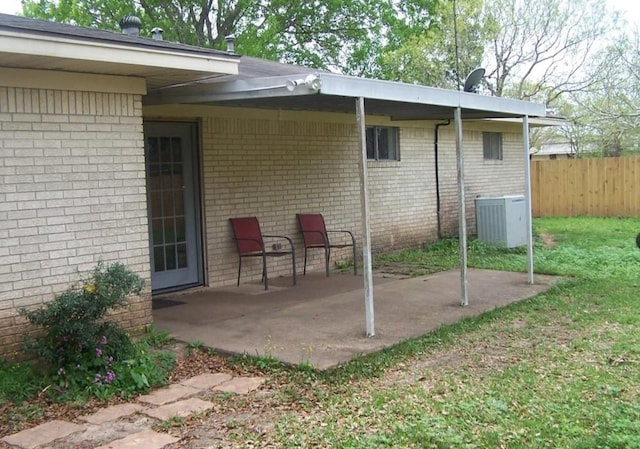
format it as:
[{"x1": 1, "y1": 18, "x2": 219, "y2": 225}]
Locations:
[{"x1": 202, "y1": 113, "x2": 360, "y2": 285}]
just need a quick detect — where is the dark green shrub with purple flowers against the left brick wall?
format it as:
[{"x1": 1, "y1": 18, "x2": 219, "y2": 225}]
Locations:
[{"x1": 20, "y1": 263, "x2": 164, "y2": 393}]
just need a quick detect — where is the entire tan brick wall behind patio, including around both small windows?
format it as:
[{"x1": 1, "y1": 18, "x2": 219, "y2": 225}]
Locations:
[{"x1": 145, "y1": 106, "x2": 524, "y2": 286}]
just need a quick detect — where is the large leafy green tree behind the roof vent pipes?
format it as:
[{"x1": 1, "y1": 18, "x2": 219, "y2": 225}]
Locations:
[{"x1": 23, "y1": 0, "x2": 396, "y2": 73}]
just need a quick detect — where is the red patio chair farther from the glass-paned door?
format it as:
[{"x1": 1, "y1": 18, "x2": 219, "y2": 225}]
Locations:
[{"x1": 297, "y1": 214, "x2": 358, "y2": 276}]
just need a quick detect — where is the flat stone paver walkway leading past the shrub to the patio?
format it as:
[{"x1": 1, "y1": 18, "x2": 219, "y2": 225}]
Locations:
[{"x1": 0, "y1": 373, "x2": 265, "y2": 449}]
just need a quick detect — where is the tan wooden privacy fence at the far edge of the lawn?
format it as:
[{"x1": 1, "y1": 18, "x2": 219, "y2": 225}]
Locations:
[{"x1": 531, "y1": 157, "x2": 640, "y2": 217}]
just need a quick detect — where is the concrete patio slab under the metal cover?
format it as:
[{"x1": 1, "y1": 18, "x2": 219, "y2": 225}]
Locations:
[{"x1": 154, "y1": 269, "x2": 555, "y2": 369}]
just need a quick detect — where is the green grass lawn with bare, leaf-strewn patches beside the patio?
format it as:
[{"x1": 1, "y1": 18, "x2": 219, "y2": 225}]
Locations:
[{"x1": 229, "y1": 218, "x2": 640, "y2": 449}]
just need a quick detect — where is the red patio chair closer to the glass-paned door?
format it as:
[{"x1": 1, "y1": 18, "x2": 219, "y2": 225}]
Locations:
[{"x1": 229, "y1": 217, "x2": 296, "y2": 290}]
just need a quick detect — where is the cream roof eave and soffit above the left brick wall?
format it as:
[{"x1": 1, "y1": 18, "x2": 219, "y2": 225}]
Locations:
[{"x1": 0, "y1": 14, "x2": 239, "y2": 89}]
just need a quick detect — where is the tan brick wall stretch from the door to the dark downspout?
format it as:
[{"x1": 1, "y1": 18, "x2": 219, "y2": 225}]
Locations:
[{"x1": 202, "y1": 112, "x2": 436, "y2": 285}]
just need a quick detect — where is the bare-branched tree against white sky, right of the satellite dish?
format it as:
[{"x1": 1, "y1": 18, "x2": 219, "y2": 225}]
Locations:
[{"x1": 485, "y1": 0, "x2": 612, "y2": 105}]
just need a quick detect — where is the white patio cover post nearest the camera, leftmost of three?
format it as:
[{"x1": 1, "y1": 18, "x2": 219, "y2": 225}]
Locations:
[{"x1": 353, "y1": 97, "x2": 376, "y2": 337}]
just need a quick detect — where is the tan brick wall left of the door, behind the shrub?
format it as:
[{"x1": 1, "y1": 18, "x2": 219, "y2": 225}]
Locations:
[{"x1": 0, "y1": 86, "x2": 151, "y2": 353}]
